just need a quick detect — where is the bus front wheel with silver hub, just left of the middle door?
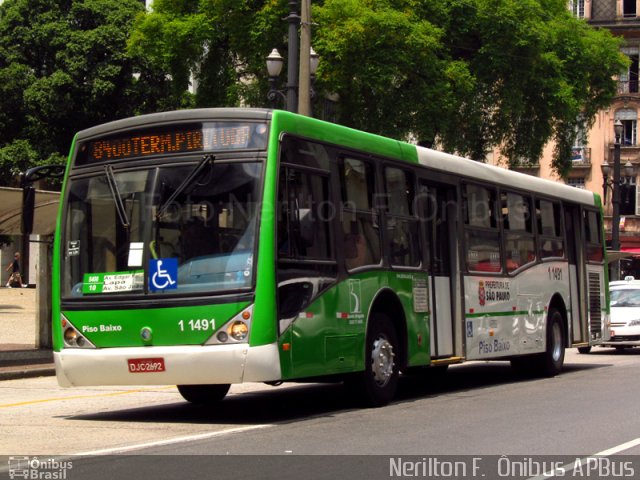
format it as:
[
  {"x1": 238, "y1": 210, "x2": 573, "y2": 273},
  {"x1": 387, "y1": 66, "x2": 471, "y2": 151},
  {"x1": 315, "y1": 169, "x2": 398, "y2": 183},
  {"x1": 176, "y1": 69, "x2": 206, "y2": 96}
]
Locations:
[{"x1": 345, "y1": 313, "x2": 400, "y2": 407}]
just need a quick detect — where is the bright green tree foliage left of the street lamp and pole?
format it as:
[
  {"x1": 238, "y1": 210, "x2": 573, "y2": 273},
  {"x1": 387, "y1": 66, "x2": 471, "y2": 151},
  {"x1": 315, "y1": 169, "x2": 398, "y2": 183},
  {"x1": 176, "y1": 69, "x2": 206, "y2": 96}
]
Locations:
[{"x1": 129, "y1": 0, "x2": 287, "y2": 107}]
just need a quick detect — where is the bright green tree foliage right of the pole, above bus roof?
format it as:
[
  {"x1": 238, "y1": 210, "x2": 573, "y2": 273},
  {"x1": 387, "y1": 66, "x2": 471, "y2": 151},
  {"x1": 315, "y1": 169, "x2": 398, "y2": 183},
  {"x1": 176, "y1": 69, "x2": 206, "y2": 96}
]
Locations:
[{"x1": 314, "y1": 0, "x2": 626, "y2": 176}]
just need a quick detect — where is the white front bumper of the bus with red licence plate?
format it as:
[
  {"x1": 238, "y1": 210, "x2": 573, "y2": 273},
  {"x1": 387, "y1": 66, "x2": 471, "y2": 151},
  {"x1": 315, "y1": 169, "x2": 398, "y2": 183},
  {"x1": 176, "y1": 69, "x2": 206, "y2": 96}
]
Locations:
[{"x1": 53, "y1": 343, "x2": 281, "y2": 387}]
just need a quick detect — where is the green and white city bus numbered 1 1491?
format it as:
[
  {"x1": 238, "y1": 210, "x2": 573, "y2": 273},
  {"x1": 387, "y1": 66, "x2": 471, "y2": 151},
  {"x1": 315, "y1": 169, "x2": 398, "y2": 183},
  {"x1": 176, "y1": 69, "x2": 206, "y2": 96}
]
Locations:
[{"x1": 53, "y1": 109, "x2": 608, "y2": 406}]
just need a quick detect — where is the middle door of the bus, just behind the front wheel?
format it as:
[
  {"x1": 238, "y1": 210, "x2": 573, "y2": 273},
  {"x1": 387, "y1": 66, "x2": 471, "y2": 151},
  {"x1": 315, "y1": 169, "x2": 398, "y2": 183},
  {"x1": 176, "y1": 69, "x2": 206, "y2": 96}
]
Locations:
[{"x1": 420, "y1": 181, "x2": 459, "y2": 359}]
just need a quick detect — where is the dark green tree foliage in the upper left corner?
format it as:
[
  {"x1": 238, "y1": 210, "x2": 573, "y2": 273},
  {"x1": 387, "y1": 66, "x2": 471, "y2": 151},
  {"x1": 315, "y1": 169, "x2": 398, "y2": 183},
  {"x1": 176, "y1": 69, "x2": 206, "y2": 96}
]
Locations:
[{"x1": 0, "y1": 0, "x2": 148, "y2": 184}]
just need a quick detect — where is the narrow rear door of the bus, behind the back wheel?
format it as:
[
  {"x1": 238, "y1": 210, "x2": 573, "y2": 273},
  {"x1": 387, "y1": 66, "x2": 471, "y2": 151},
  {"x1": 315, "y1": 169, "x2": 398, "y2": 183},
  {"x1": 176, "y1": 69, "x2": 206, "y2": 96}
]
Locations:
[{"x1": 564, "y1": 204, "x2": 589, "y2": 343}]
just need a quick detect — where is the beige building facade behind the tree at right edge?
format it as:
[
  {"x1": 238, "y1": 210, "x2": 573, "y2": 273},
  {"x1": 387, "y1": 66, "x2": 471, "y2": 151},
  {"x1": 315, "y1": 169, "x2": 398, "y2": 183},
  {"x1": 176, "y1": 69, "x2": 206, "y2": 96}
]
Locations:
[{"x1": 489, "y1": 0, "x2": 640, "y2": 278}]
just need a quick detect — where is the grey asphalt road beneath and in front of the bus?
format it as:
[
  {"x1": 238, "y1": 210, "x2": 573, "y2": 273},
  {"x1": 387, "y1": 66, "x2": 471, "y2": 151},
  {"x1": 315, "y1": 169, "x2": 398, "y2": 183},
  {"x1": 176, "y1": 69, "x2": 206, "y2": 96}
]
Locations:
[{"x1": 0, "y1": 349, "x2": 640, "y2": 480}]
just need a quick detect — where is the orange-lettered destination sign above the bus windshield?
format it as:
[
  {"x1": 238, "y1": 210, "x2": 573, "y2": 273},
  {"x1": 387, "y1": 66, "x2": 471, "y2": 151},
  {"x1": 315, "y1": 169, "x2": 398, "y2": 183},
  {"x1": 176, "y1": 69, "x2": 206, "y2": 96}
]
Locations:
[{"x1": 78, "y1": 123, "x2": 267, "y2": 165}]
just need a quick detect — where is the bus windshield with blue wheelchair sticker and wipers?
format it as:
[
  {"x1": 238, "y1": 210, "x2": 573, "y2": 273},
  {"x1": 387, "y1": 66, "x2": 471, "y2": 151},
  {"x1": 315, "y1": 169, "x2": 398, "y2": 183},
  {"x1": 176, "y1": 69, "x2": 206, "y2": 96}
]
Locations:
[{"x1": 61, "y1": 160, "x2": 262, "y2": 297}]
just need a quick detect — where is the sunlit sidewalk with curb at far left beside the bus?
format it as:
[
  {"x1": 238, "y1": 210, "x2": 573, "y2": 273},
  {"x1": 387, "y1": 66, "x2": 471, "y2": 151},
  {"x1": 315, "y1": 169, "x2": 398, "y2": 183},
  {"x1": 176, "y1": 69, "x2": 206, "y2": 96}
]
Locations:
[{"x1": 0, "y1": 286, "x2": 55, "y2": 380}]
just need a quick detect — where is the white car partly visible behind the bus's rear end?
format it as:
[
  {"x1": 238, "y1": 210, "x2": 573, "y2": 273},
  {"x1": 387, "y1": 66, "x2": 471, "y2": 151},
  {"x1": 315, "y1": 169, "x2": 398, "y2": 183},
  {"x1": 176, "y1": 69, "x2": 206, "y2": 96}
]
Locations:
[{"x1": 603, "y1": 278, "x2": 640, "y2": 350}]
